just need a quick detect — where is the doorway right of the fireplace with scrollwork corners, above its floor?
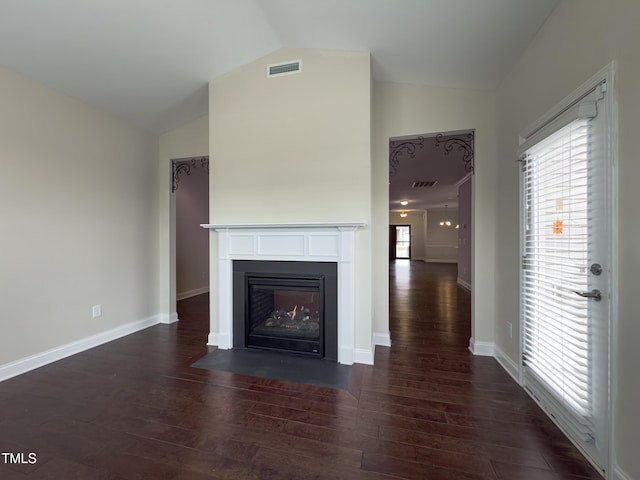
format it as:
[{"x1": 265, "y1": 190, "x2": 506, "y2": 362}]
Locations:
[{"x1": 389, "y1": 130, "x2": 475, "y2": 278}]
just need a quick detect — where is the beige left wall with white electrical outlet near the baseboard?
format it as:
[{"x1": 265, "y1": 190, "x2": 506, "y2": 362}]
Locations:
[{"x1": 0, "y1": 62, "x2": 159, "y2": 365}]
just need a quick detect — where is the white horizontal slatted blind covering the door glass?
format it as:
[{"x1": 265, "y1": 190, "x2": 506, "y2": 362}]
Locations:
[{"x1": 521, "y1": 118, "x2": 593, "y2": 440}]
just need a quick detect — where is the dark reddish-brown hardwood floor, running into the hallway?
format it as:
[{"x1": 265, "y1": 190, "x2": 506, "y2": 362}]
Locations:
[{"x1": 0, "y1": 261, "x2": 600, "y2": 480}]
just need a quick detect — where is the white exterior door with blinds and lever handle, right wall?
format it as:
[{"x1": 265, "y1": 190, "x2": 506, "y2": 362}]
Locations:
[{"x1": 521, "y1": 72, "x2": 614, "y2": 471}]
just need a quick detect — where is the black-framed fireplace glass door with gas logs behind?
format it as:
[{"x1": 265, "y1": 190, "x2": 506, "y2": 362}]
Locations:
[{"x1": 245, "y1": 275, "x2": 324, "y2": 357}]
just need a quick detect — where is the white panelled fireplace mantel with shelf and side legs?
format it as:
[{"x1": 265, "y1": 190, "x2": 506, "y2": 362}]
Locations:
[{"x1": 201, "y1": 222, "x2": 365, "y2": 365}]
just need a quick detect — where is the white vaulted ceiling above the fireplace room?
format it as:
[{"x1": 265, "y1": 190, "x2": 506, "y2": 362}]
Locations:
[{"x1": 0, "y1": 0, "x2": 559, "y2": 133}]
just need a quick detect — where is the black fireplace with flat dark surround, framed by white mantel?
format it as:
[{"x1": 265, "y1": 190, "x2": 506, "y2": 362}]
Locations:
[{"x1": 233, "y1": 260, "x2": 338, "y2": 361}]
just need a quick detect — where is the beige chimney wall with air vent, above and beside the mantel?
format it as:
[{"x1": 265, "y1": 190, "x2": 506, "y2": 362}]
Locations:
[{"x1": 209, "y1": 49, "x2": 372, "y2": 350}]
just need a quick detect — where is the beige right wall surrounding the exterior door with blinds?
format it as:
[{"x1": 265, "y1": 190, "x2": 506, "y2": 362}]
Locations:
[{"x1": 496, "y1": 0, "x2": 640, "y2": 479}]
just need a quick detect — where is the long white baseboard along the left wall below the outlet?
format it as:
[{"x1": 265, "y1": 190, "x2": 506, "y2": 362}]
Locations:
[{"x1": 0, "y1": 315, "x2": 161, "y2": 382}]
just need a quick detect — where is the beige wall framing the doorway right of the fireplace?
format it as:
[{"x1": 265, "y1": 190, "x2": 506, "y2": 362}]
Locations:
[{"x1": 372, "y1": 83, "x2": 498, "y2": 346}]
